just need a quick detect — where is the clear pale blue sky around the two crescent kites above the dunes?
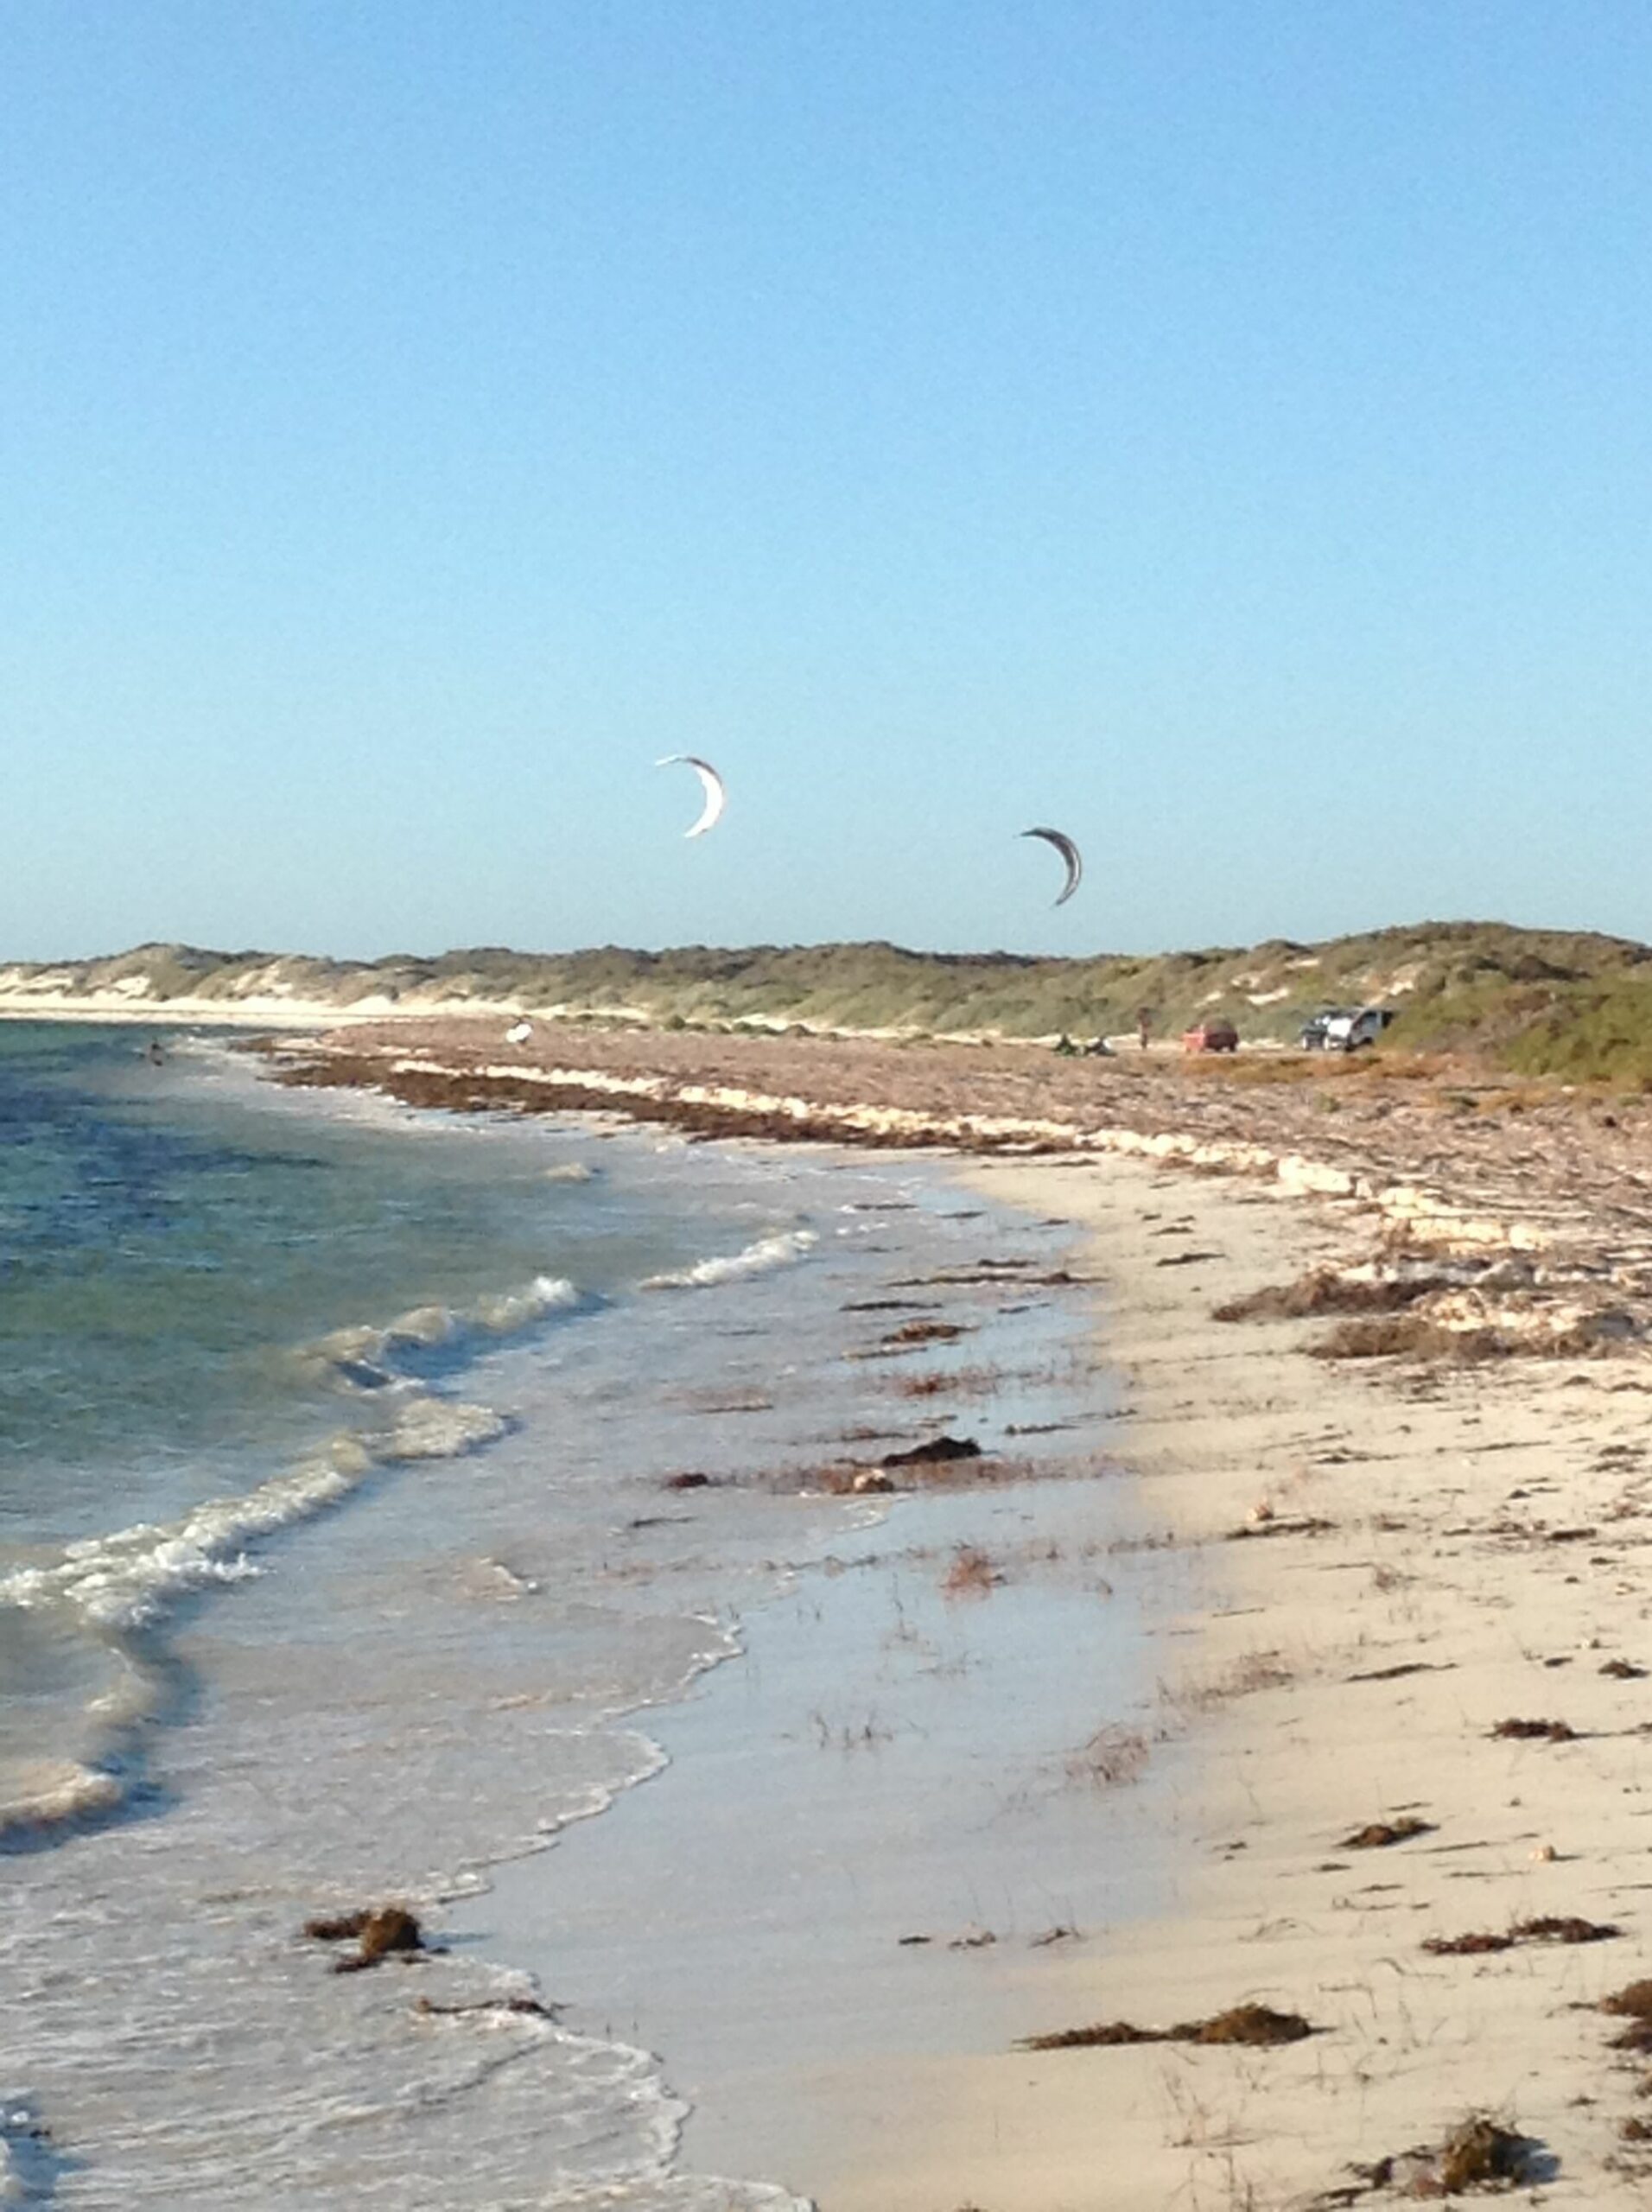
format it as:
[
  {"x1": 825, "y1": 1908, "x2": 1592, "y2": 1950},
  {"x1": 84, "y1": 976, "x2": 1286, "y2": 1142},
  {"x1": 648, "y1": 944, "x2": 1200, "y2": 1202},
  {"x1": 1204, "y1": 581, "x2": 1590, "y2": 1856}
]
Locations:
[{"x1": 0, "y1": 0, "x2": 1652, "y2": 957}]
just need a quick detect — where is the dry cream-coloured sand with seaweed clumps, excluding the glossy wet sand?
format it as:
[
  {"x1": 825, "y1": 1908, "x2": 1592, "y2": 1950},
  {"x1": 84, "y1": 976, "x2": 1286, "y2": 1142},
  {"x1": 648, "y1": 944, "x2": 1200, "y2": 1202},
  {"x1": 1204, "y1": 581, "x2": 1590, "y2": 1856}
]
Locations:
[{"x1": 807, "y1": 1161, "x2": 1652, "y2": 2212}]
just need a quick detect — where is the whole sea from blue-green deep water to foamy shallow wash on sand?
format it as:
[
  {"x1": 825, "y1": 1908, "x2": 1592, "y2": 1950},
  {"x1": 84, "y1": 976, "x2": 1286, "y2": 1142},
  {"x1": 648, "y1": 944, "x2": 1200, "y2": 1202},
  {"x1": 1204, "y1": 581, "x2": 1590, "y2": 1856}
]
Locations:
[{"x1": 0, "y1": 1024, "x2": 1123, "y2": 2212}]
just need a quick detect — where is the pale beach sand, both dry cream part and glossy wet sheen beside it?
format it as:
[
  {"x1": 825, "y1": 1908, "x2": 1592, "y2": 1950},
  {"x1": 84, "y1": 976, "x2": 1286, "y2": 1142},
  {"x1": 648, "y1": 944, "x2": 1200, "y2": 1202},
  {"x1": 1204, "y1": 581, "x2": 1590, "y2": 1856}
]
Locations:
[{"x1": 455, "y1": 1159, "x2": 1652, "y2": 2212}]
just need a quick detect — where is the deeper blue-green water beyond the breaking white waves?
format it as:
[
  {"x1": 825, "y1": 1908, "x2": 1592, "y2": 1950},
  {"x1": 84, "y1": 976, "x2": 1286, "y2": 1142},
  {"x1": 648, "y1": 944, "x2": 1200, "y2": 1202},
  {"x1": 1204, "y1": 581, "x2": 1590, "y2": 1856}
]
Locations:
[{"x1": 0, "y1": 1024, "x2": 677, "y2": 1541}]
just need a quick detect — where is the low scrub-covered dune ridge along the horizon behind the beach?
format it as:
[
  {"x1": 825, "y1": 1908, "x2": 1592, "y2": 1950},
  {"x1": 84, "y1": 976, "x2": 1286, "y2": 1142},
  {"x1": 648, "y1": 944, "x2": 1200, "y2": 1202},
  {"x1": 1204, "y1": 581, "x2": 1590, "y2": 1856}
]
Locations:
[{"x1": 0, "y1": 923, "x2": 1652, "y2": 1079}]
